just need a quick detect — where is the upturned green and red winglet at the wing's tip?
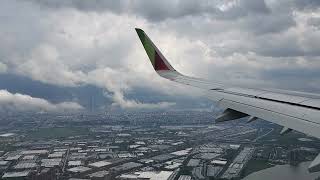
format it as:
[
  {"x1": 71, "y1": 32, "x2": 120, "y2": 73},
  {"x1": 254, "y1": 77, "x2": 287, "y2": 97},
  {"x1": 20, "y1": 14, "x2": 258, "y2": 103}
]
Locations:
[{"x1": 136, "y1": 28, "x2": 175, "y2": 71}]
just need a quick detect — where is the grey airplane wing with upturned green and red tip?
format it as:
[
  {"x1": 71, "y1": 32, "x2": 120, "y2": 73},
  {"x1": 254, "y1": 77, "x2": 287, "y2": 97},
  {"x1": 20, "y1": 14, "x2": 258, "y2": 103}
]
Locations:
[{"x1": 136, "y1": 29, "x2": 320, "y2": 172}]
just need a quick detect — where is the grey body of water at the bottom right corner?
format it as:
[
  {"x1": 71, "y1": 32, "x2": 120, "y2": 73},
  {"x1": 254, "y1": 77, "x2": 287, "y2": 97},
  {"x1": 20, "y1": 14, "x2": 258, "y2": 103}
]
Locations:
[{"x1": 243, "y1": 162, "x2": 320, "y2": 180}]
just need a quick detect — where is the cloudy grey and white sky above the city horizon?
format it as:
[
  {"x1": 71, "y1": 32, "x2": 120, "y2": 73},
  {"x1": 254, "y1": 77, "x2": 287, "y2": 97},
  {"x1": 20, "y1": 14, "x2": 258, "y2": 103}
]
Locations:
[{"x1": 0, "y1": 0, "x2": 320, "y2": 111}]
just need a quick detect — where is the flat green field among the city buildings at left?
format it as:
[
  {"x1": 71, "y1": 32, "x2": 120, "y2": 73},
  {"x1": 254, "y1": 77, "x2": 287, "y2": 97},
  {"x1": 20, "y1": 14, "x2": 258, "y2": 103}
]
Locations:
[{"x1": 27, "y1": 127, "x2": 89, "y2": 139}]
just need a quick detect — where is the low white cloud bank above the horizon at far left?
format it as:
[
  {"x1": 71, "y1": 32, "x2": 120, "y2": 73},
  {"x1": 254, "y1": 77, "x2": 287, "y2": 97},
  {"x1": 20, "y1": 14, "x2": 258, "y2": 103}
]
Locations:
[{"x1": 0, "y1": 89, "x2": 83, "y2": 112}]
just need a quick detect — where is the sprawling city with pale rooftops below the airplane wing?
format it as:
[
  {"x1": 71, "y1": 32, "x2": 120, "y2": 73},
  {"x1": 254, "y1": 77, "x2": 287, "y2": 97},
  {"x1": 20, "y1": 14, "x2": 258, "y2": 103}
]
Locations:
[{"x1": 0, "y1": 111, "x2": 320, "y2": 180}]
